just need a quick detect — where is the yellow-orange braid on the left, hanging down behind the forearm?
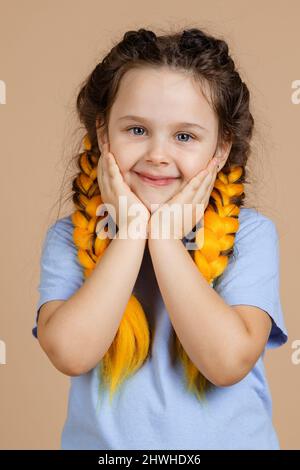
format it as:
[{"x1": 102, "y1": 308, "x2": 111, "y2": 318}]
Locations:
[{"x1": 72, "y1": 136, "x2": 150, "y2": 400}]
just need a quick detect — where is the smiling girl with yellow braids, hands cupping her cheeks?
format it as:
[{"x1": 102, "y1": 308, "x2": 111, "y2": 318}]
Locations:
[{"x1": 33, "y1": 28, "x2": 287, "y2": 450}]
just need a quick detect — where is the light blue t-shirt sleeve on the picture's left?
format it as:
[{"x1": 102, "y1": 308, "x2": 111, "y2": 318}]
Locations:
[{"x1": 32, "y1": 217, "x2": 84, "y2": 338}]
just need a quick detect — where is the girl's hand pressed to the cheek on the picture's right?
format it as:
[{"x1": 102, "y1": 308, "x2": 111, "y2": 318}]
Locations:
[{"x1": 148, "y1": 158, "x2": 219, "y2": 239}]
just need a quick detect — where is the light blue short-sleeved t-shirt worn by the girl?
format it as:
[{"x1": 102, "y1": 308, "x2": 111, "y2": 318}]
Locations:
[{"x1": 32, "y1": 208, "x2": 288, "y2": 450}]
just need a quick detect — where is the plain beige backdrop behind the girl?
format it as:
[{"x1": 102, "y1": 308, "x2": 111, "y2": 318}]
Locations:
[{"x1": 0, "y1": 0, "x2": 300, "y2": 449}]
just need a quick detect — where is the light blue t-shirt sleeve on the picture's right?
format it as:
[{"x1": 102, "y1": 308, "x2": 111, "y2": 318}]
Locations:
[{"x1": 214, "y1": 209, "x2": 288, "y2": 349}]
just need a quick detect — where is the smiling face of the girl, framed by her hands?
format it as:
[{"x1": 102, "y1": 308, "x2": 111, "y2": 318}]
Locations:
[{"x1": 98, "y1": 68, "x2": 230, "y2": 209}]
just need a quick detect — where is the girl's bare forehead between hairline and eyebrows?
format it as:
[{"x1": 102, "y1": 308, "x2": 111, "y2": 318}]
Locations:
[{"x1": 111, "y1": 67, "x2": 217, "y2": 127}]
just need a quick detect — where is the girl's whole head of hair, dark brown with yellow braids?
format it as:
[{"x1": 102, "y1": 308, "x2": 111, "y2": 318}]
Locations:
[{"x1": 67, "y1": 28, "x2": 254, "y2": 400}]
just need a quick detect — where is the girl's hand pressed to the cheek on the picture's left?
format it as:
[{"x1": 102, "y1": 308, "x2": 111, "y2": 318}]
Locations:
[{"x1": 97, "y1": 142, "x2": 151, "y2": 234}]
